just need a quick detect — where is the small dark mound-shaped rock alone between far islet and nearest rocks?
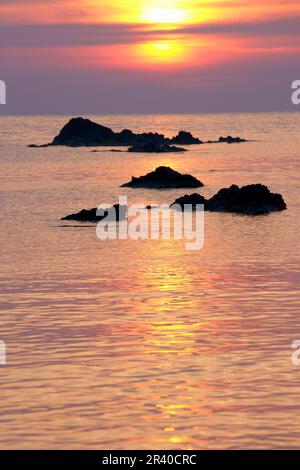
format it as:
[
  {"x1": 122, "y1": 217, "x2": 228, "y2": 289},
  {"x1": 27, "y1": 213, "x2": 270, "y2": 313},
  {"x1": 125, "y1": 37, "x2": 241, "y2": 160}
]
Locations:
[{"x1": 122, "y1": 166, "x2": 203, "y2": 189}]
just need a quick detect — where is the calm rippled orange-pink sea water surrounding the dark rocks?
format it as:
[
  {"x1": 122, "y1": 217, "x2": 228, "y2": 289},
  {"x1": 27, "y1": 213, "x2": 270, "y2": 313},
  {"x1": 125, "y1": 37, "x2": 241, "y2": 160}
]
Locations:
[{"x1": 0, "y1": 113, "x2": 300, "y2": 449}]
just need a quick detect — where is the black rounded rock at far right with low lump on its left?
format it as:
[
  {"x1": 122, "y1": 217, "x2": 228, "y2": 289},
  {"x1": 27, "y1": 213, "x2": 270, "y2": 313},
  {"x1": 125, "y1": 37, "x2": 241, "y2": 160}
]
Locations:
[{"x1": 170, "y1": 184, "x2": 287, "y2": 215}]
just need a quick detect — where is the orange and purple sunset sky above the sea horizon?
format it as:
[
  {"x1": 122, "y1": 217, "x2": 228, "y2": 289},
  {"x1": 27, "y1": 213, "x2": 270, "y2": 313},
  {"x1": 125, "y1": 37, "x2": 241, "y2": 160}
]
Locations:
[{"x1": 0, "y1": 0, "x2": 300, "y2": 114}]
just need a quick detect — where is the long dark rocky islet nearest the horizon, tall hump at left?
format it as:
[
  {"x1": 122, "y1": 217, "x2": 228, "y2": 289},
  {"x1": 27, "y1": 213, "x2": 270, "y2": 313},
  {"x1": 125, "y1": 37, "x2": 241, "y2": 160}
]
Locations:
[{"x1": 30, "y1": 117, "x2": 201, "y2": 147}]
